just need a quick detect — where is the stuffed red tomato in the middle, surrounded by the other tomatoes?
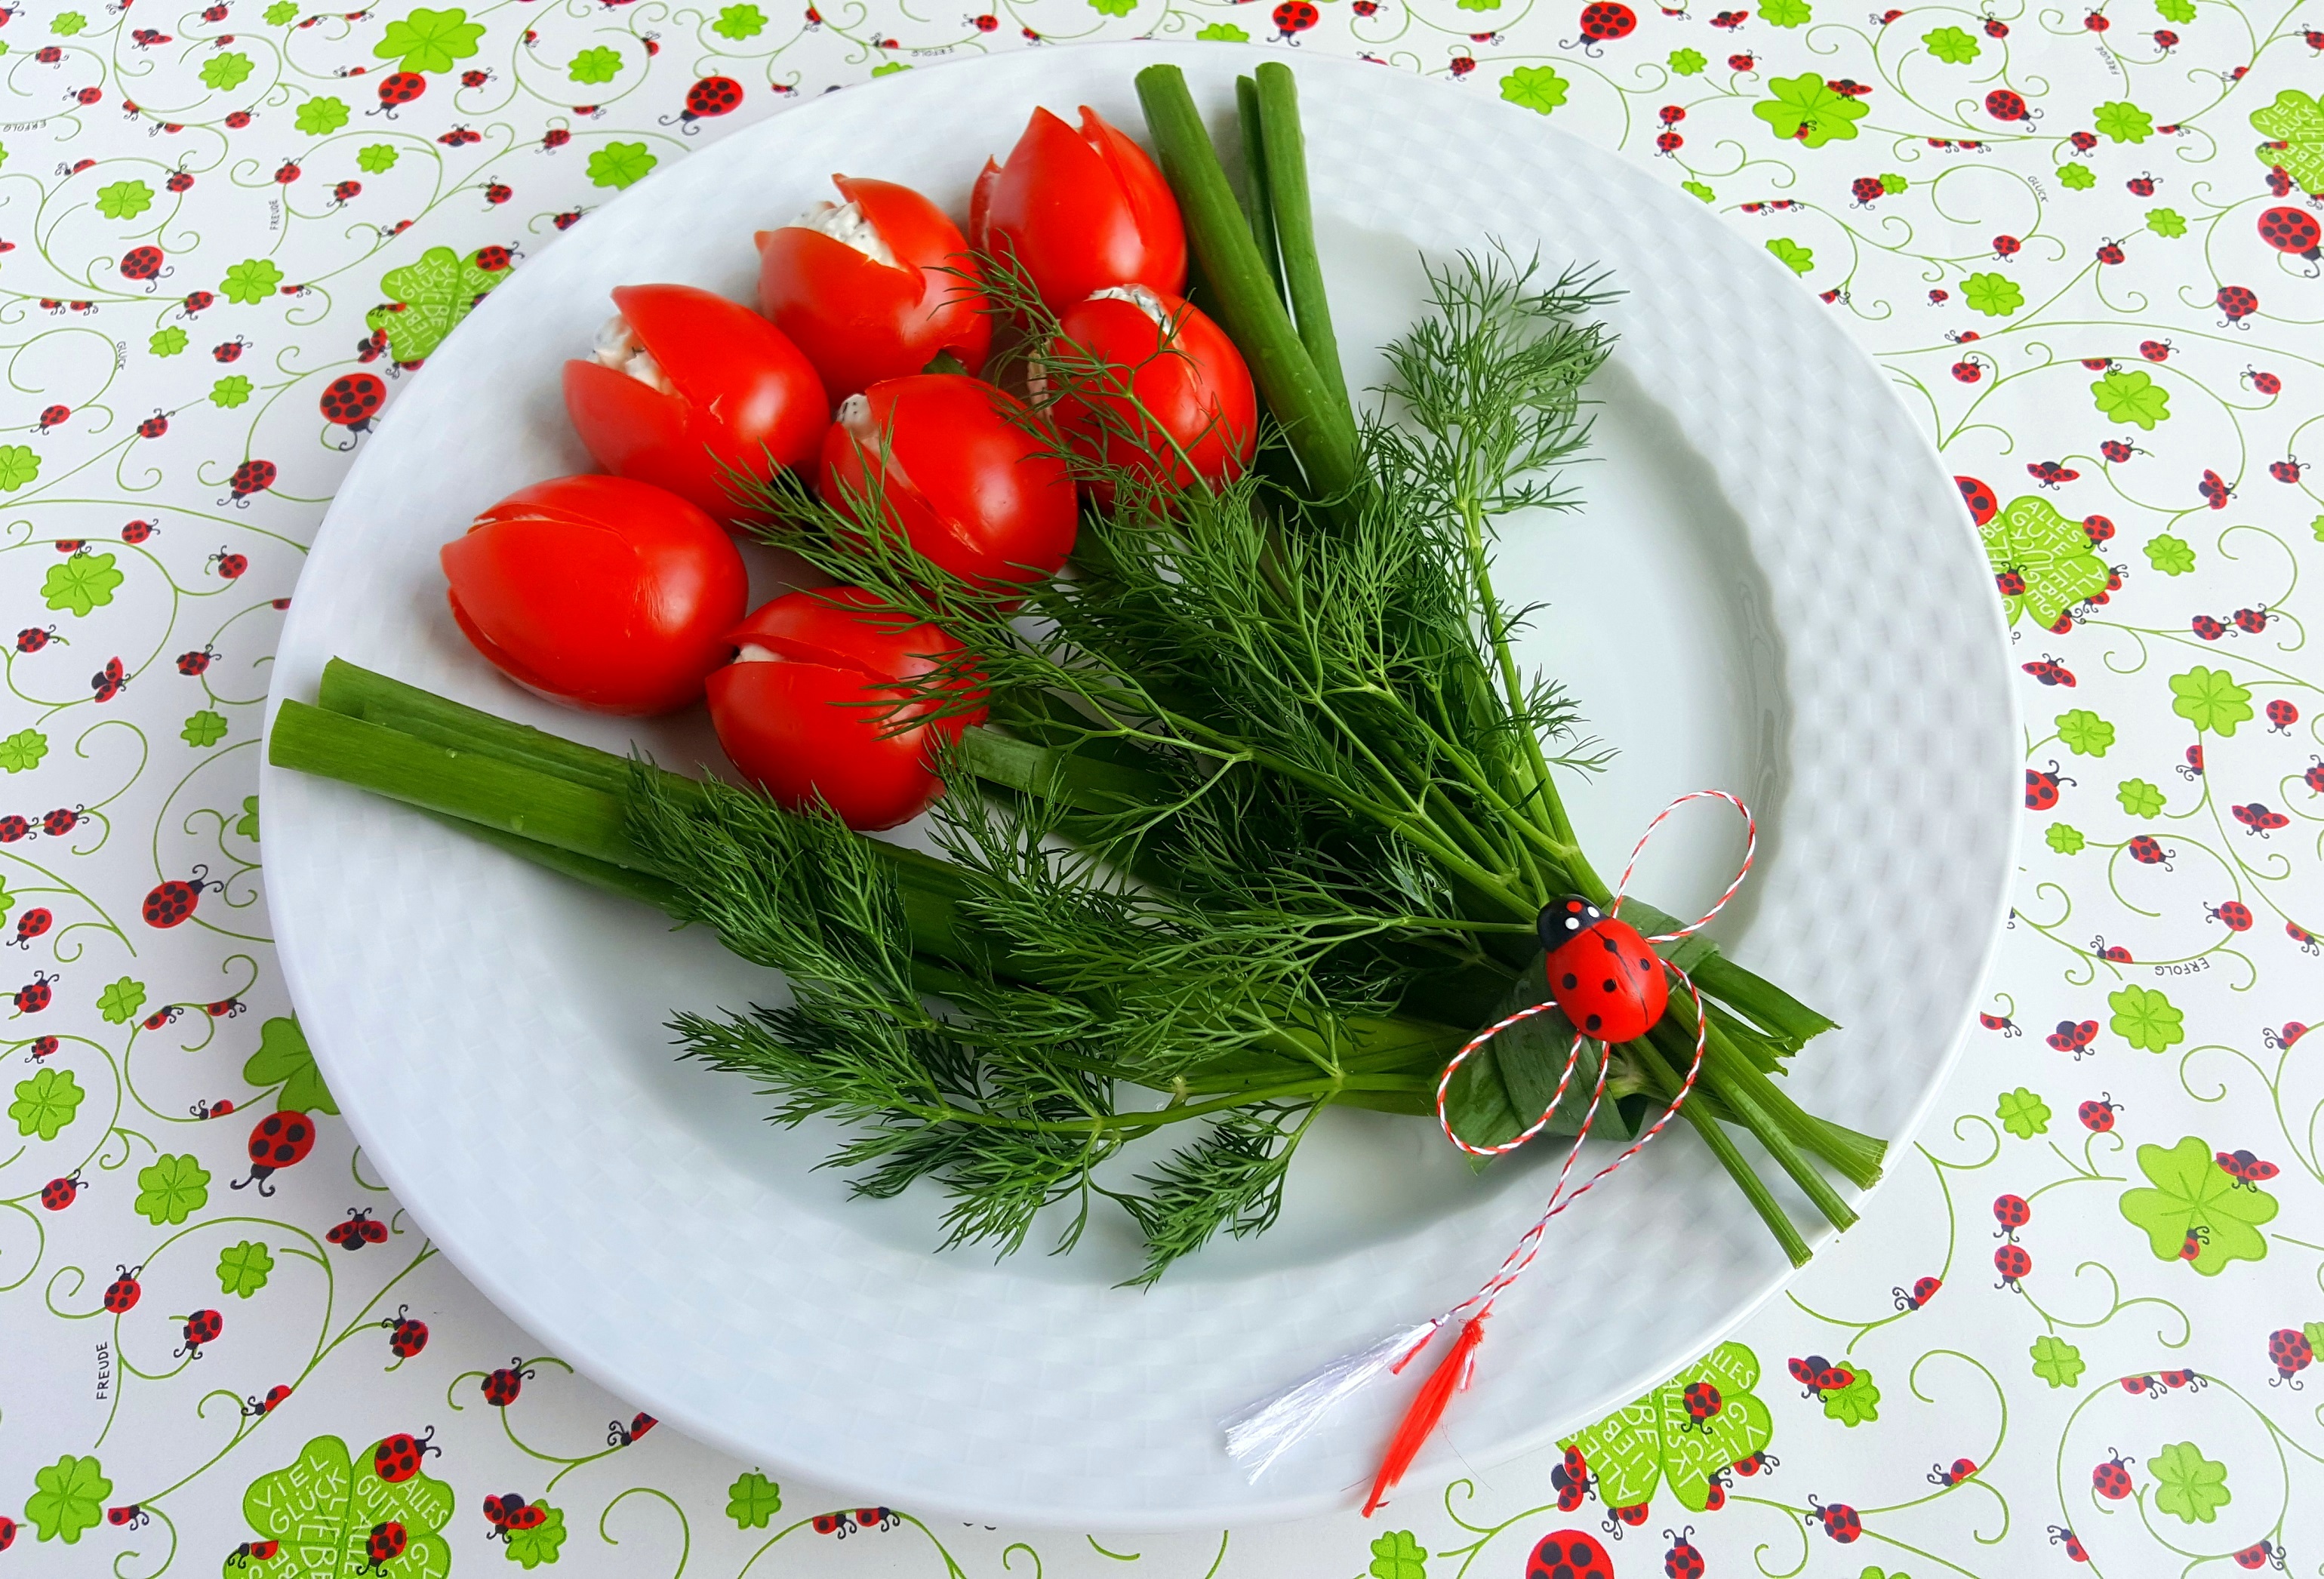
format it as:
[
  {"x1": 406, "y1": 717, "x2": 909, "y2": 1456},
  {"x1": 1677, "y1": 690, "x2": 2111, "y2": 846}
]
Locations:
[{"x1": 820, "y1": 372, "x2": 1076, "y2": 586}]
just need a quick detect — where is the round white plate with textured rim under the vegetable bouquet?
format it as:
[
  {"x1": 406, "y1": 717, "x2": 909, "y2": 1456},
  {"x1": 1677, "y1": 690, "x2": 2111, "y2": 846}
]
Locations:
[{"x1": 263, "y1": 45, "x2": 2018, "y2": 1530}]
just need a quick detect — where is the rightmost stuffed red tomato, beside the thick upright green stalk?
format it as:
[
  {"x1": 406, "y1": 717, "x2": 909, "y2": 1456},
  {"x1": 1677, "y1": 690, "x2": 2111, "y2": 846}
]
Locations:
[{"x1": 1051, "y1": 286, "x2": 1260, "y2": 488}]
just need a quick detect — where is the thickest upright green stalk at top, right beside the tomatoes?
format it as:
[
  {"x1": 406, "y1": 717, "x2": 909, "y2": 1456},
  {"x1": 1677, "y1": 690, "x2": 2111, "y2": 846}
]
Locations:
[{"x1": 1139, "y1": 65, "x2": 1359, "y2": 500}]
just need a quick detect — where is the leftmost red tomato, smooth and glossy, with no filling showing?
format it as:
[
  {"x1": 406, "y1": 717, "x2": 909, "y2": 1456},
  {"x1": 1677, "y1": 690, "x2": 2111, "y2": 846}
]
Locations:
[{"x1": 442, "y1": 477, "x2": 751, "y2": 716}]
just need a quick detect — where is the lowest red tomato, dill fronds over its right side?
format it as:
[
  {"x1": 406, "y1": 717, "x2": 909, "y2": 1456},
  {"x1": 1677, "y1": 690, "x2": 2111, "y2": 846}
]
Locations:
[{"x1": 709, "y1": 586, "x2": 985, "y2": 830}]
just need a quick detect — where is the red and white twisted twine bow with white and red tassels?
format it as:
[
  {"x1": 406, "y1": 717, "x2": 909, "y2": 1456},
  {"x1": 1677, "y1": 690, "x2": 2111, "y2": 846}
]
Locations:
[{"x1": 1225, "y1": 791, "x2": 1759, "y2": 1514}]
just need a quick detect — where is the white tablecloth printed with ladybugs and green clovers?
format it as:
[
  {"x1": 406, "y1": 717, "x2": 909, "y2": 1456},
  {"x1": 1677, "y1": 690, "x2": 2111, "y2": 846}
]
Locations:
[{"x1": 0, "y1": 0, "x2": 2324, "y2": 1579}]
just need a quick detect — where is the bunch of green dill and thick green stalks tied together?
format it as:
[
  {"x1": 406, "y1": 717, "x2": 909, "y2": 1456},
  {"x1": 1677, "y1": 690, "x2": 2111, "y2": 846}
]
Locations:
[{"x1": 269, "y1": 65, "x2": 1882, "y2": 1284}]
